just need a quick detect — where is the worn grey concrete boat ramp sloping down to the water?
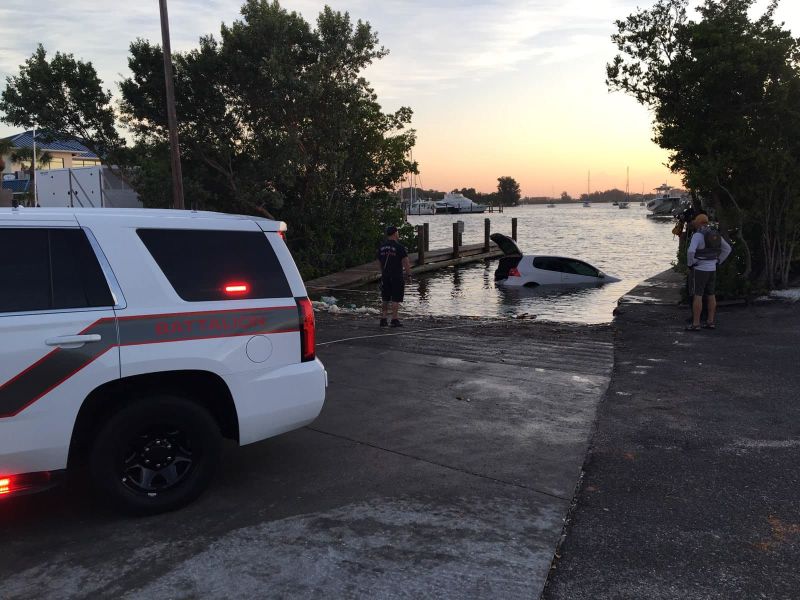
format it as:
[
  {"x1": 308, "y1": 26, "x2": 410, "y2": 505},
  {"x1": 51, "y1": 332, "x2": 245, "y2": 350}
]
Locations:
[{"x1": 0, "y1": 315, "x2": 613, "y2": 599}]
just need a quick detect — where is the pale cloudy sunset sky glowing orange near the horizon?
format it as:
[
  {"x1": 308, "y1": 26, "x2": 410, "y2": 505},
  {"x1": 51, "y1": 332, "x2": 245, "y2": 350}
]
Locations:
[{"x1": 0, "y1": 0, "x2": 800, "y2": 196}]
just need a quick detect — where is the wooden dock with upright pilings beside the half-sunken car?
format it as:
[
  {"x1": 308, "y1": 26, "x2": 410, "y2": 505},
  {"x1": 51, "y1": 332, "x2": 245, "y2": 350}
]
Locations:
[{"x1": 305, "y1": 218, "x2": 517, "y2": 293}]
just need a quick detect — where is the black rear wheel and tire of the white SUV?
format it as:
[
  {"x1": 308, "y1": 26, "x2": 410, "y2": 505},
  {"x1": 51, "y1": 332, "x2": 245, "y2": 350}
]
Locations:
[{"x1": 90, "y1": 396, "x2": 221, "y2": 515}]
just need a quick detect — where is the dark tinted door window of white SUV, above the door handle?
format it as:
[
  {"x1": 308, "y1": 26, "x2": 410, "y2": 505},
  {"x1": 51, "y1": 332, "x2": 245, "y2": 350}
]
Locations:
[{"x1": 0, "y1": 228, "x2": 114, "y2": 313}]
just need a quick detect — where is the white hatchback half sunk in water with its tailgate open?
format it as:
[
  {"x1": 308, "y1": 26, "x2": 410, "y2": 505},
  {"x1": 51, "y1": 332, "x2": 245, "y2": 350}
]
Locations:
[{"x1": 491, "y1": 233, "x2": 619, "y2": 287}]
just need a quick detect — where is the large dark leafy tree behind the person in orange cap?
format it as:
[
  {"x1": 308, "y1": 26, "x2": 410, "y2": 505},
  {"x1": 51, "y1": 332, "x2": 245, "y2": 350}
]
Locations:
[{"x1": 607, "y1": 0, "x2": 800, "y2": 287}]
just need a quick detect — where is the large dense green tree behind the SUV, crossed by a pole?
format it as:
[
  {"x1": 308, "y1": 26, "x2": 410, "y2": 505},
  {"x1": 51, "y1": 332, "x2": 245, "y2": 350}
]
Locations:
[{"x1": 120, "y1": 0, "x2": 414, "y2": 277}]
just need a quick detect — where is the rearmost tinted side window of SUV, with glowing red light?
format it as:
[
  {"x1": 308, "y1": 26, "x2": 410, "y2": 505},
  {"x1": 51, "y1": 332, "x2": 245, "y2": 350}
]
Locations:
[{"x1": 137, "y1": 229, "x2": 292, "y2": 302}]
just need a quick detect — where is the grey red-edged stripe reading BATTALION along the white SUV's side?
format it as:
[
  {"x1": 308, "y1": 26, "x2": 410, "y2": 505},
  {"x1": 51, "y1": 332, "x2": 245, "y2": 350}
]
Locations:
[{"x1": 0, "y1": 306, "x2": 300, "y2": 418}]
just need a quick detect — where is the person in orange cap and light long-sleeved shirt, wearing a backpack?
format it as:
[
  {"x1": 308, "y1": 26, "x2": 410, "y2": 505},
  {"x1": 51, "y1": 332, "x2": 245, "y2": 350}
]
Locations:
[{"x1": 686, "y1": 214, "x2": 731, "y2": 331}]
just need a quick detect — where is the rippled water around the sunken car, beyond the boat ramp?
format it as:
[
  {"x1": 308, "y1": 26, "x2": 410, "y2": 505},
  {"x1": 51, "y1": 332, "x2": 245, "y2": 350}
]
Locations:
[{"x1": 324, "y1": 204, "x2": 677, "y2": 323}]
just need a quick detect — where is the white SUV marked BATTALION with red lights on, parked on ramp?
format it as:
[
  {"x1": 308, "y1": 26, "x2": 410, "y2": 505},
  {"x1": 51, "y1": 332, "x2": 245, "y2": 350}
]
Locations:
[{"x1": 0, "y1": 208, "x2": 327, "y2": 514}]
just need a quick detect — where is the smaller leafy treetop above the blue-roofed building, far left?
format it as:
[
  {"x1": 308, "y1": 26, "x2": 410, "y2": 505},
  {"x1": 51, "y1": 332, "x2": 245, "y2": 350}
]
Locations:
[{"x1": 0, "y1": 44, "x2": 124, "y2": 161}]
